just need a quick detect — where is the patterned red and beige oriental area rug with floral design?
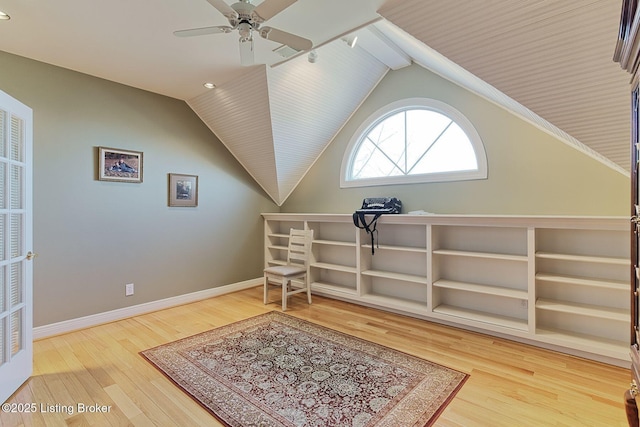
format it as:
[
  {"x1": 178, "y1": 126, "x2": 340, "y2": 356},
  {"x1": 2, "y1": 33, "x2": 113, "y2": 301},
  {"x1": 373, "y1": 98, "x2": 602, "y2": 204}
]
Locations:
[{"x1": 141, "y1": 311, "x2": 467, "y2": 427}]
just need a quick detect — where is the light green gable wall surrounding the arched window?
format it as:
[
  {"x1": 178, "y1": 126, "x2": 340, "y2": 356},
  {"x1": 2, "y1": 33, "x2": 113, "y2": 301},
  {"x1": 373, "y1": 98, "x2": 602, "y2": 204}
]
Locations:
[{"x1": 281, "y1": 65, "x2": 630, "y2": 215}]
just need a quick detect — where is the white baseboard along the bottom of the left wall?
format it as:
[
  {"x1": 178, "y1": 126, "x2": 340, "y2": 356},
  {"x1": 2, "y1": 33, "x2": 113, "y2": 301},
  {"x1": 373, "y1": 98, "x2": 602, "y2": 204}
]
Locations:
[{"x1": 33, "y1": 277, "x2": 263, "y2": 340}]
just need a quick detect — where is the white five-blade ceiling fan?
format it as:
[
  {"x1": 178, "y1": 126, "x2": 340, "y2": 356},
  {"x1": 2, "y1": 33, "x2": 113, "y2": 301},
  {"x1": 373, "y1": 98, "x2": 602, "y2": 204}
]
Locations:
[{"x1": 173, "y1": 0, "x2": 313, "y2": 65}]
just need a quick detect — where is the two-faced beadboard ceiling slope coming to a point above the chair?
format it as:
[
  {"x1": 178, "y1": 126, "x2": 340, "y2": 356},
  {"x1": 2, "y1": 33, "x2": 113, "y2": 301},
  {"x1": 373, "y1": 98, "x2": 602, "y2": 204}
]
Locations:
[{"x1": 187, "y1": 33, "x2": 388, "y2": 206}]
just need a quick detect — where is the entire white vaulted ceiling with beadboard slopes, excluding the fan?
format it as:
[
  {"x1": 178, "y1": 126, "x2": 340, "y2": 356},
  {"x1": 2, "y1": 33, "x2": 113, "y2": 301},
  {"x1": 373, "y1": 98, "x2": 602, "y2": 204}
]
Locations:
[{"x1": 0, "y1": 0, "x2": 629, "y2": 204}]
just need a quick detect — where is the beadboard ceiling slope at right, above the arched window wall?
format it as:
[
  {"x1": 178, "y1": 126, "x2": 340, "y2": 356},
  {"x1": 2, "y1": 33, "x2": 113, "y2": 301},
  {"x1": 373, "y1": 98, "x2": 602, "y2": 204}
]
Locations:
[{"x1": 378, "y1": 0, "x2": 630, "y2": 171}]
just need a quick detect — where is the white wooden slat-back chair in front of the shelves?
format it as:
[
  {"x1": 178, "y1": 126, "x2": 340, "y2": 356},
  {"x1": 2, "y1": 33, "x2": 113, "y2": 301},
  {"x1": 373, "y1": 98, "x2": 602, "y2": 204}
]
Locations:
[{"x1": 264, "y1": 228, "x2": 313, "y2": 311}]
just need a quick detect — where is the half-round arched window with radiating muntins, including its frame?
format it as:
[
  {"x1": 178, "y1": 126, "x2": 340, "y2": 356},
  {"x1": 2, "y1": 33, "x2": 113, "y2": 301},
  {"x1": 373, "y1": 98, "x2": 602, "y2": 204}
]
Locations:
[{"x1": 340, "y1": 98, "x2": 487, "y2": 187}]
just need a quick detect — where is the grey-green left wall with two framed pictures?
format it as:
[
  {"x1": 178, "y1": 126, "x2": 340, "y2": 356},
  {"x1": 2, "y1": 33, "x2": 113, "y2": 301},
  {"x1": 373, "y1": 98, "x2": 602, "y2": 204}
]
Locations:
[{"x1": 0, "y1": 52, "x2": 278, "y2": 326}]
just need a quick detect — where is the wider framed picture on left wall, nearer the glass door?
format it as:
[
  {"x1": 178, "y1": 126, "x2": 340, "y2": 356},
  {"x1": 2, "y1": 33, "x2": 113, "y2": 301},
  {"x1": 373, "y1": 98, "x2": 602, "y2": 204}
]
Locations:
[{"x1": 98, "y1": 147, "x2": 142, "y2": 182}]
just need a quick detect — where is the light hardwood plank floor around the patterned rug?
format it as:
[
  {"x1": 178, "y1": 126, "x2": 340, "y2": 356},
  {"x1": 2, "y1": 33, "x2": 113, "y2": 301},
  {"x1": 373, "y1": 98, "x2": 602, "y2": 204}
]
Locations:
[{"x1": 0, "y1": 287, "x2": 630, "y2": 427}]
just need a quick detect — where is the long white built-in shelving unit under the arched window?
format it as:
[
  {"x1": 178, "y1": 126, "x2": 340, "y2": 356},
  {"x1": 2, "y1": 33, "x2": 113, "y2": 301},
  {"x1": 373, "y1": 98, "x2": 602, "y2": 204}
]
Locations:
[{"x1": 263, "y1": 214, "x2": 630, "y2": 365}]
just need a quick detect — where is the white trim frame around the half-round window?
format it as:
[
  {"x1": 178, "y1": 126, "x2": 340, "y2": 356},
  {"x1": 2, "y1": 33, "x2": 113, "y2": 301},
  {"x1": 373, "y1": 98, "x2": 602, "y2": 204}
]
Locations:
[{"x1": 340, "y1": 98, "x2": 488, "y2": 188}]
